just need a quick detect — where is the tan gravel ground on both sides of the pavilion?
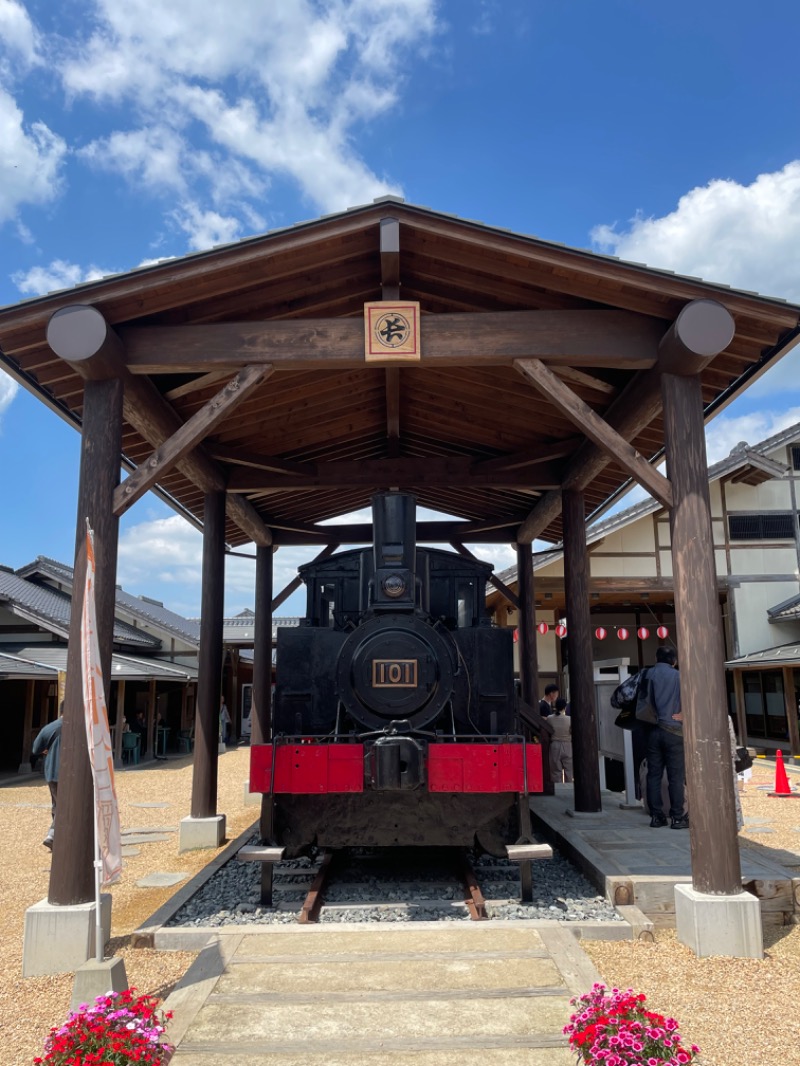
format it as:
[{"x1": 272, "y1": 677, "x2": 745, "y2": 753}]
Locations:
[{"x1": 0, "y1": 748, "x2": 800, "y2": 1066}]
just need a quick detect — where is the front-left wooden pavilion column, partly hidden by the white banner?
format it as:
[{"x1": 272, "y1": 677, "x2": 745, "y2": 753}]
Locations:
[{"x1": 48, "y1": 377, "x2": 123, "y2": 906}]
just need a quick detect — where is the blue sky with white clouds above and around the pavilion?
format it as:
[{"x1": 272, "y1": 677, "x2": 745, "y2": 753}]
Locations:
[{"x1": 0, "y1": 0, "x2": 800, "y2": 614}]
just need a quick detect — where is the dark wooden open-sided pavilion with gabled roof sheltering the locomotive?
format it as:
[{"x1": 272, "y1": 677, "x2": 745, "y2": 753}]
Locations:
[{"x1": 0, "y1": 198, "x2": 800, "y2": 933}]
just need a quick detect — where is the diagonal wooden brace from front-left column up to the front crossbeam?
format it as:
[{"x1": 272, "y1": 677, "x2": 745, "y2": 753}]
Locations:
[{"x1": 114, "y1": 367, "x2": 273, "y2": 517}]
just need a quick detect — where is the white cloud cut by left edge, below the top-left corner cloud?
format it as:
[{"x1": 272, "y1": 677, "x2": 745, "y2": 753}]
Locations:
[{"x1": 0, "y1": 88, "x2": 67, "y2": 225}]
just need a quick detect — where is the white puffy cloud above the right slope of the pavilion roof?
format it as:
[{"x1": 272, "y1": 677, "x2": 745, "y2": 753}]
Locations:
[{"x1": 592, "y1": 160, "x2": 800, "y2": 301}]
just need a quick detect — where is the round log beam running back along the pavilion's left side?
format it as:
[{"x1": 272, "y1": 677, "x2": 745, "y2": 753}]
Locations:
[{"x1": 47, "y1": 305, "x2": 272, "y2": 545}]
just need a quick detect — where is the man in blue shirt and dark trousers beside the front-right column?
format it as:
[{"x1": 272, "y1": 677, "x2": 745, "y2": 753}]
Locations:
[{"x1": 646, "y1": 646, "x2": 689, "y2": 829}]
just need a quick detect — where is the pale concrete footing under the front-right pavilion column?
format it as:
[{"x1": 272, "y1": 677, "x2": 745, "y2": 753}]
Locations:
[{"x1": 675, "y1": 885, "x2": 764, "y2": 958}]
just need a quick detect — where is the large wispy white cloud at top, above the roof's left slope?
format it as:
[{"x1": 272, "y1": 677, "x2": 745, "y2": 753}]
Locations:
[{"x1": 54, "y1": 0, "x2": 437, "y2": 224}]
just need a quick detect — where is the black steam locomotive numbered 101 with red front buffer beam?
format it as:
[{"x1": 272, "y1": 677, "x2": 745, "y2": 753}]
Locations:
[{"x1": 250, "y1": 492, "x2": 542, "y2": 856}]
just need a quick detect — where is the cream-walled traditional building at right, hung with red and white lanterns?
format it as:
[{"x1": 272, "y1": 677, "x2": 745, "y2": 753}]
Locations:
[{"x1": 486, "y1": 423, "x2": 800, "y2": 756}]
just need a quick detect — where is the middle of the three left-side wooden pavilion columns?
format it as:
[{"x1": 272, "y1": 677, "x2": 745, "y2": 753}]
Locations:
[{"x1": 192, "y1": 492, "x2": 225, "y2": 818}]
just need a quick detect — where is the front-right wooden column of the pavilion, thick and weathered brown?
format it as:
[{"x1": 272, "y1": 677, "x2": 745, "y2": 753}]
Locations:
[{"x1": 661, "y1": 368, "x2": 741, "y2": 895}]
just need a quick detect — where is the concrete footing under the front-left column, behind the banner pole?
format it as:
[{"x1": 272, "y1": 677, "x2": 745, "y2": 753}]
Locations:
[{"x1": 22, "y1": 892, "x2": 111, "y2": 978}]
